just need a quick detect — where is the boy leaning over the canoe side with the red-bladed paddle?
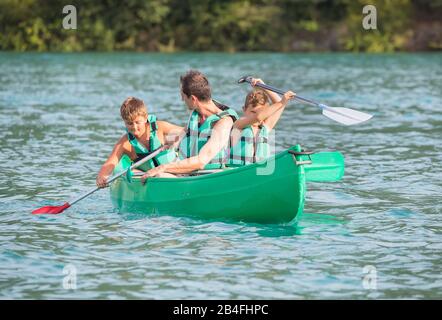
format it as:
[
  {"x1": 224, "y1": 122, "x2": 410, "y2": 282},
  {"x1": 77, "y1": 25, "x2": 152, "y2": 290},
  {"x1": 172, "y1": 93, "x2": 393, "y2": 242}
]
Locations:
[{"x1": 96, "y1": 97, "x2": 184, "y2": 188}]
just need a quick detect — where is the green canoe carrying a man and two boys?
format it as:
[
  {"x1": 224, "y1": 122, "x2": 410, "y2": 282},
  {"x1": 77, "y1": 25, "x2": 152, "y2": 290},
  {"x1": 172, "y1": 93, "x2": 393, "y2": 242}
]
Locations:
[{"x1": 110, "y1": 145, "x2": 344, "y2": 223}]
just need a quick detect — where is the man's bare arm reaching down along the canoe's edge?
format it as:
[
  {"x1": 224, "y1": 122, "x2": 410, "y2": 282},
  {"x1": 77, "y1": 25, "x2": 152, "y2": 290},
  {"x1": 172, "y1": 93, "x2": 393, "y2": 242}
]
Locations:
[{"x1": 142, "y1": 117, "x2": 233, "y2": 181}]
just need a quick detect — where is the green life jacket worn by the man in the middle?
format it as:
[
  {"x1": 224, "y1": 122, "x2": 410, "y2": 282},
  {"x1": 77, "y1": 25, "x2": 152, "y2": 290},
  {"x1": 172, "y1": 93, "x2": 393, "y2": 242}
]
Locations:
[{"x1": 178, "y1": 104, "x2": 238, "y2": 169}]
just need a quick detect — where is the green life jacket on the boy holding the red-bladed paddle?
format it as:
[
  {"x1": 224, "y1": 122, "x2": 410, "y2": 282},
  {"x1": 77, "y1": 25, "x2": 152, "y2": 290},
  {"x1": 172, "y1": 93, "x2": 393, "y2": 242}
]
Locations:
[{"x1": 126, "y1": 114, "x2": 177, "y2": 171}]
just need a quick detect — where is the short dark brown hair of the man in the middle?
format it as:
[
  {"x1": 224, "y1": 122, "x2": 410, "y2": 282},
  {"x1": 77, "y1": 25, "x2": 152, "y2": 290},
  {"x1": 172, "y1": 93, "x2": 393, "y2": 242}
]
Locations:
[{"x1": 180, "y1": 70, "x2": 212, "y2": 101}]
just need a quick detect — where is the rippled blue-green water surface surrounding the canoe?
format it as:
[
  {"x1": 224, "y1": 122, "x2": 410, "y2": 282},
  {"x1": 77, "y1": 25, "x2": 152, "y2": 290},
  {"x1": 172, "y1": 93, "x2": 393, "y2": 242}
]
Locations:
[{"x1": 0, "y1": 53, "x2": 442, "y2": 299}]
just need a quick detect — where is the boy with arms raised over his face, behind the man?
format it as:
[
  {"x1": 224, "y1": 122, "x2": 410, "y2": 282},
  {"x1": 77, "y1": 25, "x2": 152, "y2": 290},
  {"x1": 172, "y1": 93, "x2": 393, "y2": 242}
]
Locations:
[{"x1": 227, "y1": 78, "x2": 295, "y2": 166}]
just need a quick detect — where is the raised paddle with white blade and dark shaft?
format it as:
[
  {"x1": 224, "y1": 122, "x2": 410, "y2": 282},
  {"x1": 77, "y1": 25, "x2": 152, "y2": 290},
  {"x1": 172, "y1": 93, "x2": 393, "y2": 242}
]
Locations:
[{"x1": 238, "y1": 76, "x2": 373, "y2": 126}]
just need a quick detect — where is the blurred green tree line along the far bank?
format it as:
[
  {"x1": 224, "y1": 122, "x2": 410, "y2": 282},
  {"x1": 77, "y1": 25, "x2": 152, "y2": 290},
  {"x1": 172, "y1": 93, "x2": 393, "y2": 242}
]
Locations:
[{"x1": 0, "y1": 0, "x2": 442, "y2": 52}]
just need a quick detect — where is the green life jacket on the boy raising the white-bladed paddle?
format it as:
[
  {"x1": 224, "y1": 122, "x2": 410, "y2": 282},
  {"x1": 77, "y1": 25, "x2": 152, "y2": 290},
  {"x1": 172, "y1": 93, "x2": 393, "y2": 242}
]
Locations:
[{"x1": 227, "y1": 125, "x2": 270, "y2": 166}]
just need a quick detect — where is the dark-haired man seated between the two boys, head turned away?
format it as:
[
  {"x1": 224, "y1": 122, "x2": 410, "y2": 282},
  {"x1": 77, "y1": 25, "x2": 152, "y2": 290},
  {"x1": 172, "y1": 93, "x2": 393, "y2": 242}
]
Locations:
[{"x1": 142, "y1": 70, "x2": 238, "y2": 181}]
